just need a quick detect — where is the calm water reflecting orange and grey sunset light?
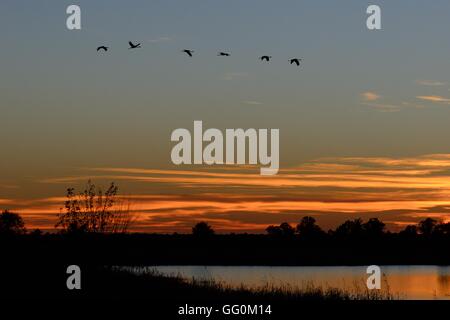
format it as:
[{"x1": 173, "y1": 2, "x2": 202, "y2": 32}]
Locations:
[{"x1": 134, "y1": 266, "x2": 450, "y2": 300}]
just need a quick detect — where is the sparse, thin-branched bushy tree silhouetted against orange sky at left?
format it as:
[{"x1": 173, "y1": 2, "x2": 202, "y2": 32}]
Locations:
[{"x1": 56, "y1": 180, "x2": 132, "y2": 233}]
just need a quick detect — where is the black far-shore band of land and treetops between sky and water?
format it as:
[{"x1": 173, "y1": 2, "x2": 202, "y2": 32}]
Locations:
[{"x1": 0, "y1": 213, "x2": 450, "y2": 266}]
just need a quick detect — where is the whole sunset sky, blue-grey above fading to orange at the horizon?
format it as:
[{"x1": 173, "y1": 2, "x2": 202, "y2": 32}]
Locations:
[{"x1": 0, "y1": 0, "x2": 450, "y2": 232}]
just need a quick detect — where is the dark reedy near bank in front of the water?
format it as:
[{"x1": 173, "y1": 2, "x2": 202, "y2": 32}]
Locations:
[{"x1": 0, "y1": 258, "x2": 400, "y2": 303}]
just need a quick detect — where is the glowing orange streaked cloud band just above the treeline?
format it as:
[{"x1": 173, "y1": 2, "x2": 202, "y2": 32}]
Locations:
[{"x1": 0, "y1": 154, "x2": 450, "y2": 232}]
